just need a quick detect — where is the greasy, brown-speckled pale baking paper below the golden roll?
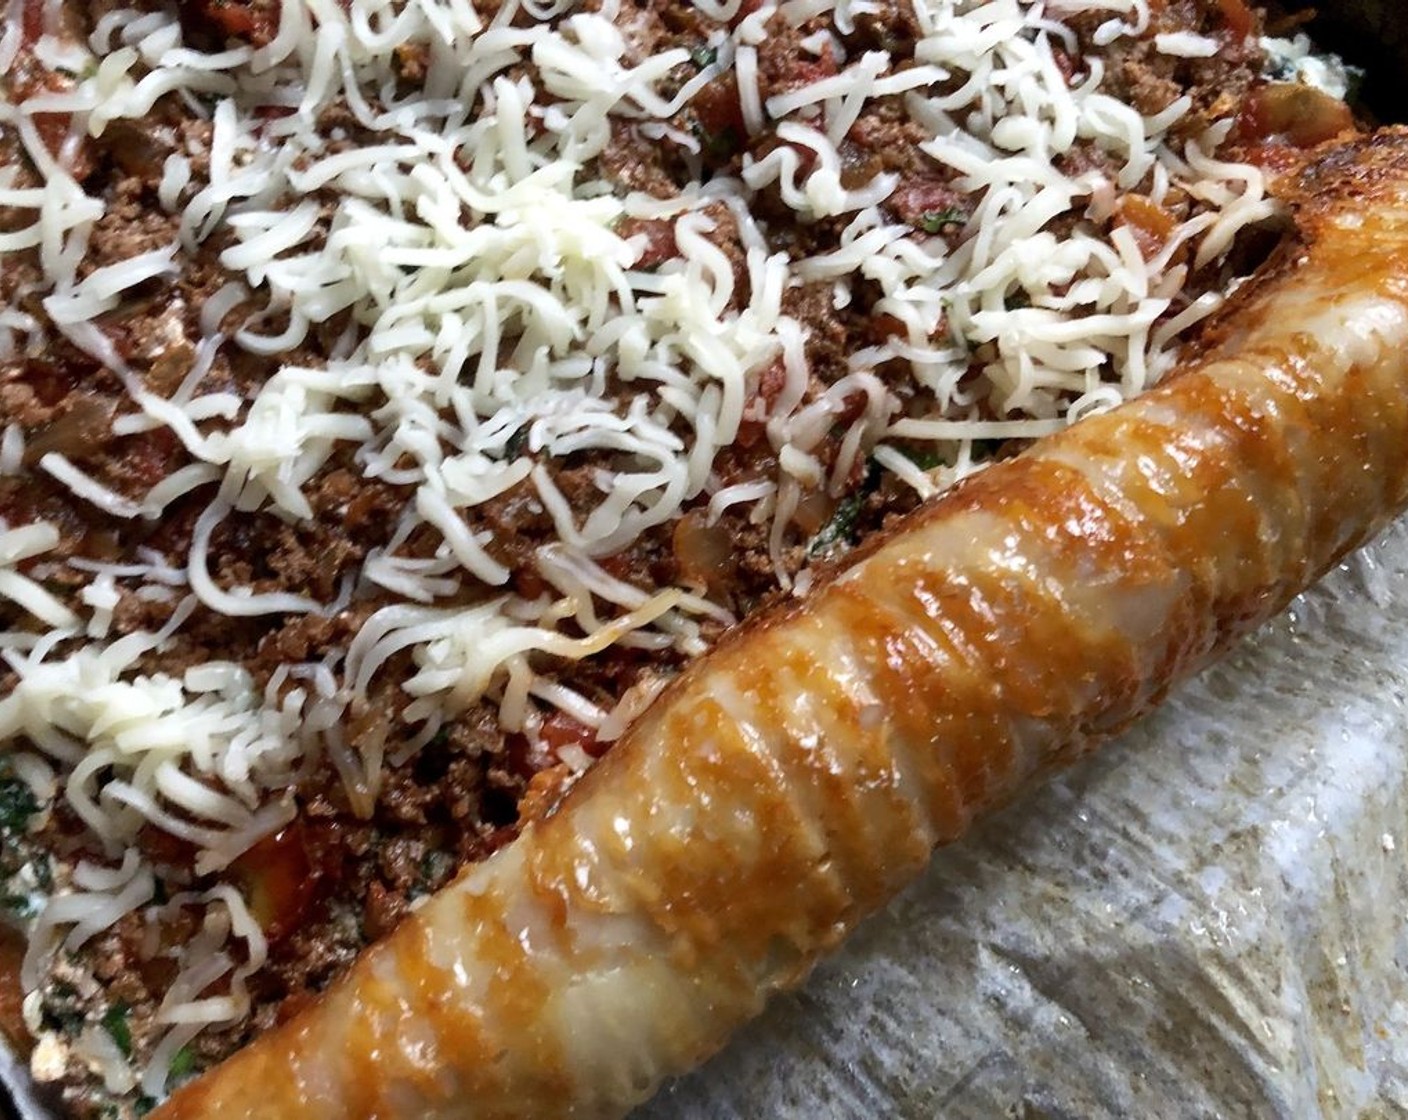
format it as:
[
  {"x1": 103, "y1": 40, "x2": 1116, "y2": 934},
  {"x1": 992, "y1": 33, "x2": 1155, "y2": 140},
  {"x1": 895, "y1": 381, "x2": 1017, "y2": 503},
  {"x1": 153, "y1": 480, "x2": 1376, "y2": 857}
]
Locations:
[{"x1": 635, "y1": 520, "x2": 1408, "y2": 1120}]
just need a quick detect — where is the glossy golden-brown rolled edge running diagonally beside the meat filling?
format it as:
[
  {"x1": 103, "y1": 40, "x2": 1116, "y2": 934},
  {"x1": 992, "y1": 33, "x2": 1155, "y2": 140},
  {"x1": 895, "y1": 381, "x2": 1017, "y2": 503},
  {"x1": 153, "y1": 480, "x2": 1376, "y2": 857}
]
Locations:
[{"x1": 156, "y1": 130, "x2": 1408, "y2": 1120}]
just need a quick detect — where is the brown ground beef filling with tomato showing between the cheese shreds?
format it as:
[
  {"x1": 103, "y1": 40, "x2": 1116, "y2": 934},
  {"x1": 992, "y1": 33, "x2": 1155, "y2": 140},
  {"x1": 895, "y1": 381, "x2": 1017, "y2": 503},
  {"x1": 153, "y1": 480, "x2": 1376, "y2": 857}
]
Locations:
[{"x1": 0, "y1": 0, "x2": 1323, "y2": 1117}]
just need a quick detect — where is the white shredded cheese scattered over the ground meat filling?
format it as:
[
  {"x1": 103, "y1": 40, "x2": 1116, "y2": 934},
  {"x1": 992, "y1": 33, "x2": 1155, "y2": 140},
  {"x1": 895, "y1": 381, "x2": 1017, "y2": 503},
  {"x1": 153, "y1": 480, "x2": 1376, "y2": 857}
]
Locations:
[{"x1": 0, "y1": 0, "x2": 1271, "y2": 1095}]
